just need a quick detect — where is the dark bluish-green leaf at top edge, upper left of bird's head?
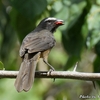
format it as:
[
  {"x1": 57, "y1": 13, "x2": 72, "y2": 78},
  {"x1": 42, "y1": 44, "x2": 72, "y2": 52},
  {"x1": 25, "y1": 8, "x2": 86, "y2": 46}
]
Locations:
[{"x1": 11, "y1": 0, "x2": 47, "y2": 19}]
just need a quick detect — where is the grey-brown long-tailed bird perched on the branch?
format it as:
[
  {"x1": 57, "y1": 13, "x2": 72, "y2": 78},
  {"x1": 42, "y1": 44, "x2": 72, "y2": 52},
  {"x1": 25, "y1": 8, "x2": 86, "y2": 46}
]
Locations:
[{"x1": 14, "y1": 17, "x2": 64, "y2": 92}]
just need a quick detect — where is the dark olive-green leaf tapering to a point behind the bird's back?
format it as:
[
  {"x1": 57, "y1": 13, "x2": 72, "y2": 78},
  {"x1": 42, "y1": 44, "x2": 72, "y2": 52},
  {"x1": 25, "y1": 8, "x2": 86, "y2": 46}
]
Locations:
[{"x1": 10, "y1": 8, "x2": 36, "y2": 42}]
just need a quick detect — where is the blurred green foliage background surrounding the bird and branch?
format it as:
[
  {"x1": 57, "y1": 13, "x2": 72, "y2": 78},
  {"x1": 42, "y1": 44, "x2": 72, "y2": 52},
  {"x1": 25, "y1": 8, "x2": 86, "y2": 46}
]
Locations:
[{"x1": 0, "y1": 0, "x2": 100, "y2": 100}]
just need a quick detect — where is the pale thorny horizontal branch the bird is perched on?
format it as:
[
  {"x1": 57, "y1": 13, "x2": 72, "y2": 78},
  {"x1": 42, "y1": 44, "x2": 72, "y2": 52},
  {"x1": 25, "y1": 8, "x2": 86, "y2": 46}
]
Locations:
[{"x1": 0, "y1": 71, "x2": 100, "y2": 81}]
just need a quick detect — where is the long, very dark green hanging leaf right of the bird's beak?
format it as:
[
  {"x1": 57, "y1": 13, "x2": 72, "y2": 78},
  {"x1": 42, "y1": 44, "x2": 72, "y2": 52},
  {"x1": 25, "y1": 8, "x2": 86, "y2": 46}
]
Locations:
[{"x1": 62, "y1": 0, "x2": 90, "y2": 69}]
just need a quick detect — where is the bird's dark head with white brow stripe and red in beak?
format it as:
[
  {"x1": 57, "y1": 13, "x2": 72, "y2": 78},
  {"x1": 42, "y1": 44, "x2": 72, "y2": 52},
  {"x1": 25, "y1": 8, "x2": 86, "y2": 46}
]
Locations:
[{"x1": 38, "y1": 17, "x2": 64, "y2": 32}]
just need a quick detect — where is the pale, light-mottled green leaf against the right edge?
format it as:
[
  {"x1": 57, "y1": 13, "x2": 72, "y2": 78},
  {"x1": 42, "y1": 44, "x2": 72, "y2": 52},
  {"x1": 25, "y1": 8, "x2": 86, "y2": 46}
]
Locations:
[{"x1": 87, "y1": 5, "x2": 100, "y2": 48}]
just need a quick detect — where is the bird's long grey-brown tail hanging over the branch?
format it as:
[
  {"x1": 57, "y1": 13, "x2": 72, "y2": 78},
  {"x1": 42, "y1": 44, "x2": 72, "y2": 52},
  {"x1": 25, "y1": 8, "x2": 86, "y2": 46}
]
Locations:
[{"x1": 15, "y1": 52, "x2": 40, "y2": 92}]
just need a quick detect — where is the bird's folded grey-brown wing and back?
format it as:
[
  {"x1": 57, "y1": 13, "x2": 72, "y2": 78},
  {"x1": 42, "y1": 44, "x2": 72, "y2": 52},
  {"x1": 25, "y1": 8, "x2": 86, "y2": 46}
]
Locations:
[{"x1": 20, "y1": 31, "x2": 55, "y2": 57}]
